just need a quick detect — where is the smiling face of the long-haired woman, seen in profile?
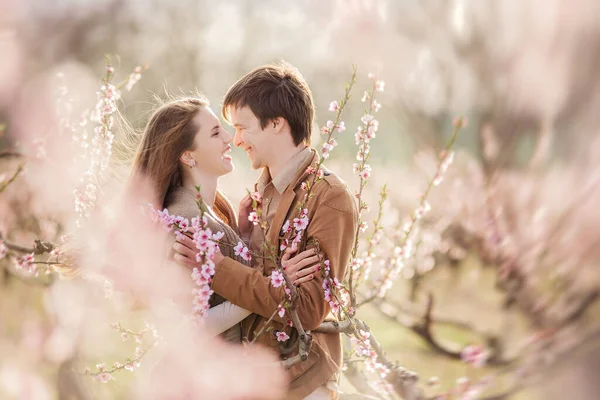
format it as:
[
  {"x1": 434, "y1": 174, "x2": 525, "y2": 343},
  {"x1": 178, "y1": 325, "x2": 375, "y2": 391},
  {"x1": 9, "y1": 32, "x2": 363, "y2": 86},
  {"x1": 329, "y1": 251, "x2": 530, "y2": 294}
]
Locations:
[{"x1": 189, "y1": 107, "x2": 233, "y2": 176}]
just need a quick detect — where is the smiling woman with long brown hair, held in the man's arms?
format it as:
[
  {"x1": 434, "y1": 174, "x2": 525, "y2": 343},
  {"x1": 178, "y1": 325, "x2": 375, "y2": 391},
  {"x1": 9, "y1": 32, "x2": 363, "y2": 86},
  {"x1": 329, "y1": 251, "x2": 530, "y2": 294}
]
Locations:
[{"x1": 132, "y1": 97, "x2": 317, "y2": 342}]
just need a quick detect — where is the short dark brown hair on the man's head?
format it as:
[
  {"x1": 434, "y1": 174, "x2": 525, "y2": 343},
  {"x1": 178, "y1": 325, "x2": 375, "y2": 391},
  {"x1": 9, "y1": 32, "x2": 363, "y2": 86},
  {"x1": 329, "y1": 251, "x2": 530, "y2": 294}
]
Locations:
[{"x1": 222, "y1": 63, "x2": 315, "y2": 146}]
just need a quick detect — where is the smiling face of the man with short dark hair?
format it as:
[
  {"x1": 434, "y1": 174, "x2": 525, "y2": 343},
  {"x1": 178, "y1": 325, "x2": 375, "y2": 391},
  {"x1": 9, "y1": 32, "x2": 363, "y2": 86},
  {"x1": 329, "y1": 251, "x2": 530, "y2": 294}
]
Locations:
[{"x1": 230, "y1": 106, "x2": 274, "y2": 169}]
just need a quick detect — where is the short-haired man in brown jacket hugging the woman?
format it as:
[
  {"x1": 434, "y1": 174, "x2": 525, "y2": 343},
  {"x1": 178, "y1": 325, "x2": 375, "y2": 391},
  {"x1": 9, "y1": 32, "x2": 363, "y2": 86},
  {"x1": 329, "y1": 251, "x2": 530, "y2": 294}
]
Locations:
[{"x1": 179, "y1": 64, "x2": 357, "y2": 399}]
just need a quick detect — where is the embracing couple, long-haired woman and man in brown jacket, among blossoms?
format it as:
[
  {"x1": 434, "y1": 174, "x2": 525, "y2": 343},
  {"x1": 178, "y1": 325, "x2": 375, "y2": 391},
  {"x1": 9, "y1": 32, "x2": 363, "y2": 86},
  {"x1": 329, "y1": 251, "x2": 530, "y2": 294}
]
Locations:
[{"x1": 134, "y1": 64, "x2": 358, "y2": 399}]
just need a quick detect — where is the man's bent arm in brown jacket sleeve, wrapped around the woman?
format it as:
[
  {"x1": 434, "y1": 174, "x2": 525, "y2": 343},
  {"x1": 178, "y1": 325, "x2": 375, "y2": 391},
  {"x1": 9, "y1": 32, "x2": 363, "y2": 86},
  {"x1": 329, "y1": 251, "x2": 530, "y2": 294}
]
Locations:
[{"x1": 211, "y1": 186, "x2": 357, "y2": 330}]
